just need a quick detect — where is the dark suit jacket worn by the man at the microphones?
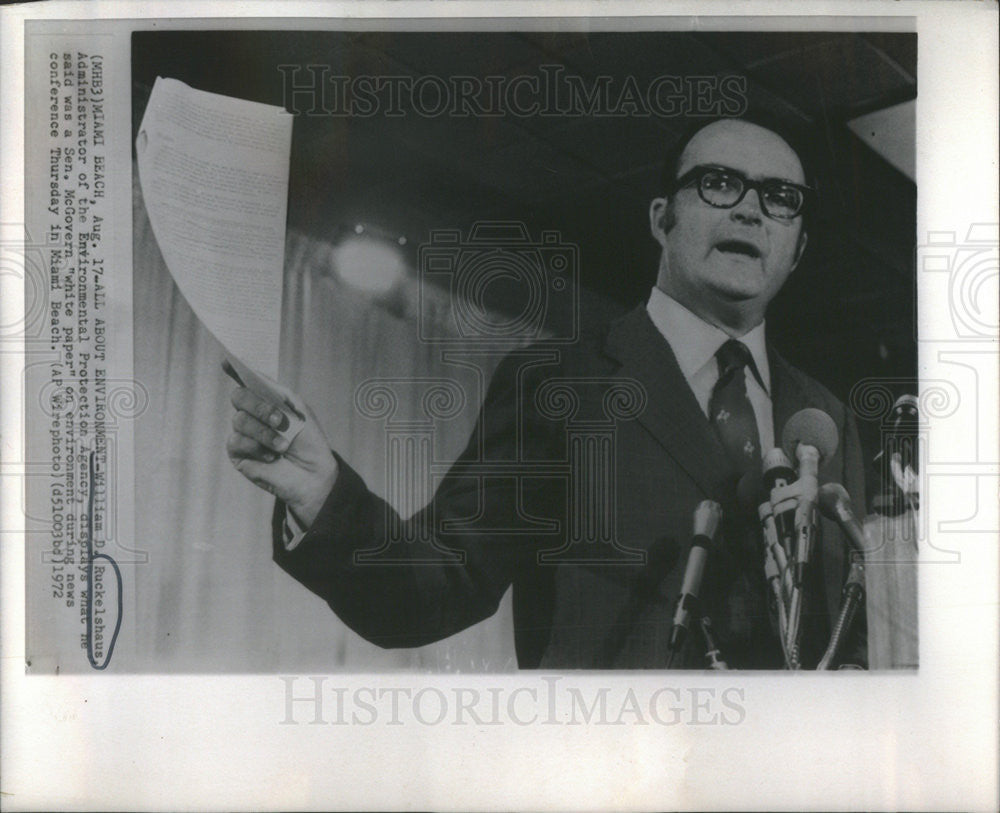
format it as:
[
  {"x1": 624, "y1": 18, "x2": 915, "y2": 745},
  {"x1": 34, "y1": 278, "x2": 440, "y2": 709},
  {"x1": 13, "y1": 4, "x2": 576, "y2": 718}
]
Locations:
[{"x1": 274, "y1": 307, "x2": 864, "y2": 669}]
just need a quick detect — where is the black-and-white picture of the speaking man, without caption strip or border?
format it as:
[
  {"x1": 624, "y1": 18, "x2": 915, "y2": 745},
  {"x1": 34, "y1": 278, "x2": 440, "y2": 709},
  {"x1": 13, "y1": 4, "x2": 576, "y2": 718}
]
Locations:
[{"x1": 119, "y1": 30, "x2": 919, "y2": 671}]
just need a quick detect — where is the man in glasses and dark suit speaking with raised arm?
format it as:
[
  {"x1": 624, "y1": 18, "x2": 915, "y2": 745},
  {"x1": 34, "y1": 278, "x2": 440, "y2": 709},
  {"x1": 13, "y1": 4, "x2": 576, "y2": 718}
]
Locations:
[{"x1": 228, "y1": 119, "x2": 864, "y2": 668}]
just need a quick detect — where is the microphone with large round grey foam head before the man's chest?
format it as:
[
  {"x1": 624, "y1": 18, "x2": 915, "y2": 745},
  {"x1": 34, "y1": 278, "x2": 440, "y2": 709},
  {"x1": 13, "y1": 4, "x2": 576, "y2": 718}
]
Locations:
[{"x1": 781, "y1": 407, "x2": 838, "y2": 586}]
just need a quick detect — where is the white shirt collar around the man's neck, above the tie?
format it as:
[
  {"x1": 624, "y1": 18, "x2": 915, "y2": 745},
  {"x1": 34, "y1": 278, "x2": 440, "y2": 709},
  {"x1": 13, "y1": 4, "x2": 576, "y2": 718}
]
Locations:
[{"x1": 646, "y1": 287, "x2": 771, "y2": 393}]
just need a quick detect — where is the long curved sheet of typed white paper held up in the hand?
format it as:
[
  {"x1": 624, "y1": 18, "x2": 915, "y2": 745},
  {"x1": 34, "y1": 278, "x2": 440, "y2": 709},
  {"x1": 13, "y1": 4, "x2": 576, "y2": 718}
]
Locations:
[{"x1": 136, "y1": 77, "x2": 293, "y2": 379}]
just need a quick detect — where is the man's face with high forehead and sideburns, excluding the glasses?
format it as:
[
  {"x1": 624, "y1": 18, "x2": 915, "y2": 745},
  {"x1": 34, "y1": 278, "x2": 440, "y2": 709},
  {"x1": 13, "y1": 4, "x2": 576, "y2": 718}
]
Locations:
[{"x1": 650, "y1": 120, "x2": 805, "y2": 330}]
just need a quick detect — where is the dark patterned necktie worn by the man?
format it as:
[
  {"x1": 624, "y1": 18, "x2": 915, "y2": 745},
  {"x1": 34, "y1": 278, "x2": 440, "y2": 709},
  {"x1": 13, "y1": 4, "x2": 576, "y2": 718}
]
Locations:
[{"x1": 708, "y1": 339, "x2": 761, "y2": 473}]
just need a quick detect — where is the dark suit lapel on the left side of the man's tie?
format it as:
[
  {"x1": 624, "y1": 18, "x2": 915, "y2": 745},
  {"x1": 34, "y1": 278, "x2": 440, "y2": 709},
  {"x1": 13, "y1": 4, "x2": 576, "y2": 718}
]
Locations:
[{"x1": 605, "y1": 306, "x2": 732, "y2": 495}]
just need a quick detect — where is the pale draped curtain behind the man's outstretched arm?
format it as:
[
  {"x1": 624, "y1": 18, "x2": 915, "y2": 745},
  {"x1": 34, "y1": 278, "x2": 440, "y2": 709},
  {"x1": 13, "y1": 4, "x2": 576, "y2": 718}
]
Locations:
[{"x1": 131, "y1": 174, "x2": 516, "y2": 672}]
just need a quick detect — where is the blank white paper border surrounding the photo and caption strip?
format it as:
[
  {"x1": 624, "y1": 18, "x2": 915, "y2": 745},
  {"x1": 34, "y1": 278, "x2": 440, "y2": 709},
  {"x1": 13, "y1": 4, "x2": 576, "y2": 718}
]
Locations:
[{"x1": 0, "y1": 2, "x2": 1000, "y2": 810}]
